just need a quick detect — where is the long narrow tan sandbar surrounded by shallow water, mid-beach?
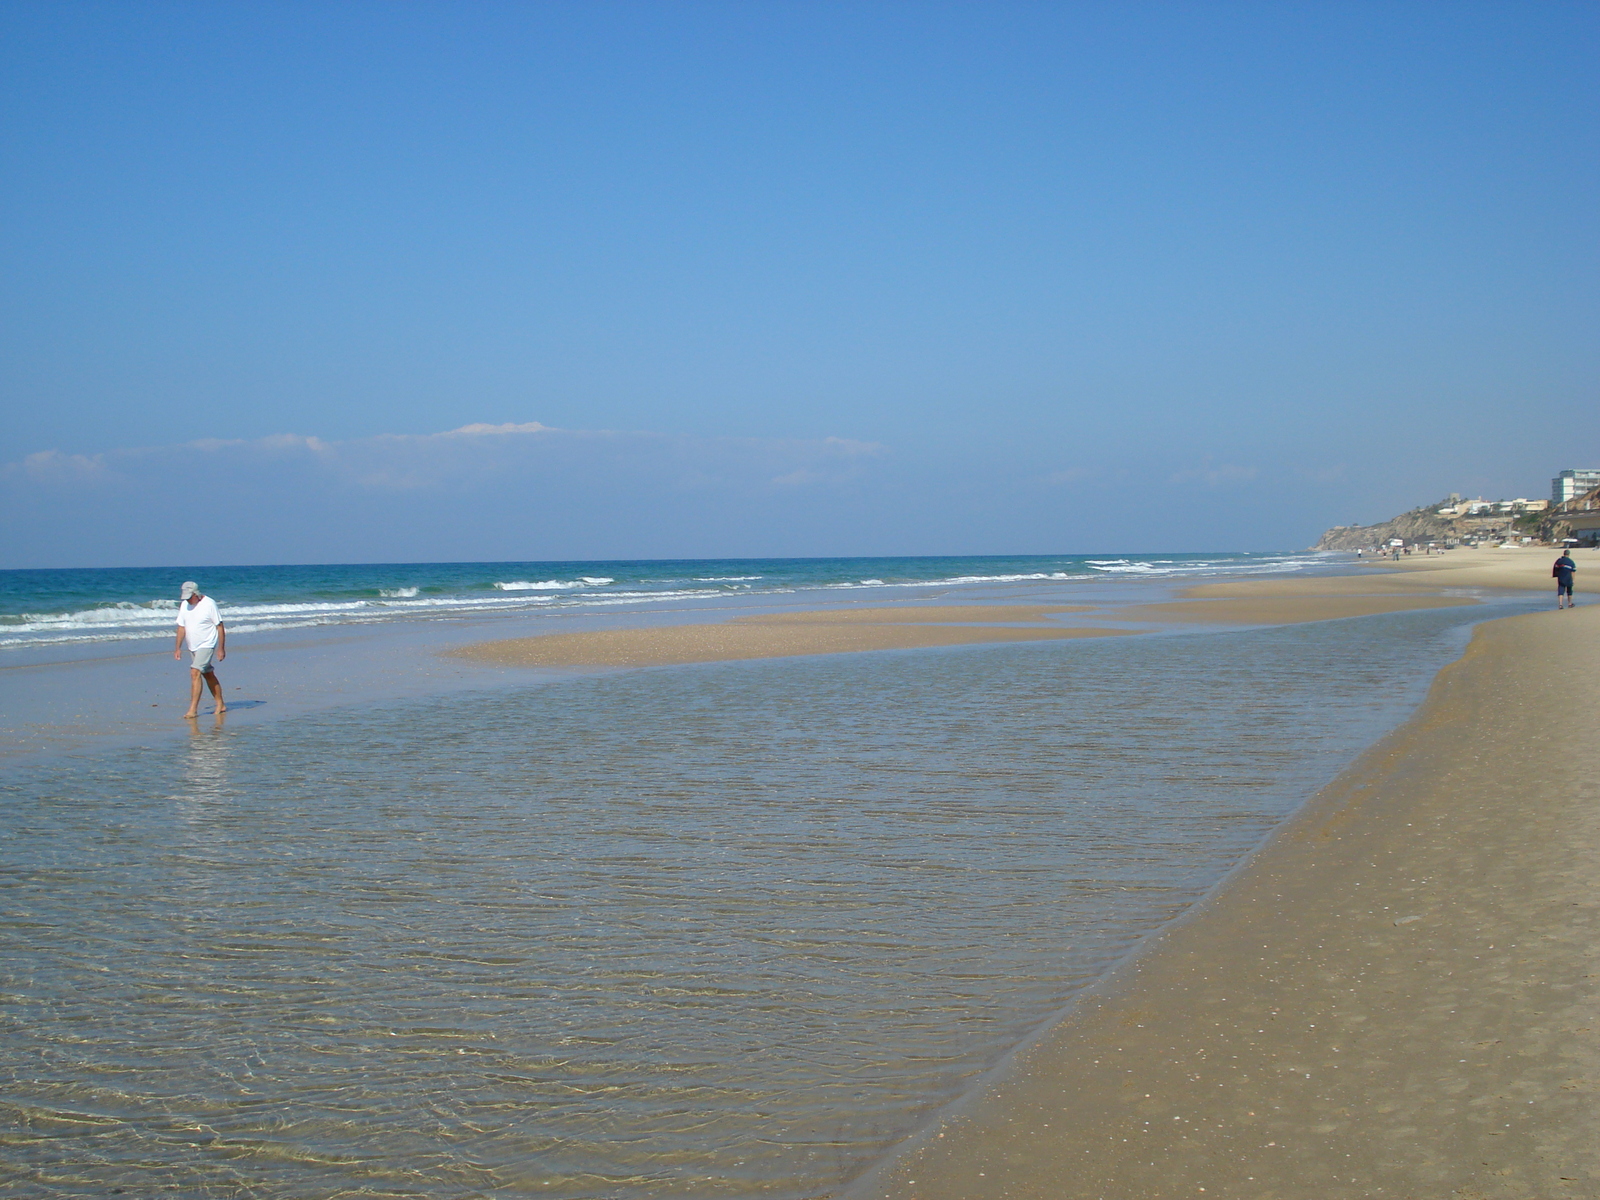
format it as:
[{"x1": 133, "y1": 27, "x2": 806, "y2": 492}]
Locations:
[{"x1": 451, "y1": 605, "x2": 1131, "y2": 667}]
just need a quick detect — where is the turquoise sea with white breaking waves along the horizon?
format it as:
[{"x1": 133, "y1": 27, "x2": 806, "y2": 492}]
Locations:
[{"x1": 0, "y1": 554, "x2": 1326, "y2": 650}]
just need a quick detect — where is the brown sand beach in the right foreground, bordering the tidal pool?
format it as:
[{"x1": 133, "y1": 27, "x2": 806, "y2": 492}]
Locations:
[{"x1": 848, "y1": 611, "x2": 1600, "y2": 1200}]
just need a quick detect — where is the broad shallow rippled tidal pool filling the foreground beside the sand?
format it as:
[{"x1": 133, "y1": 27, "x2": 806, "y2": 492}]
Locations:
[{"x1": 0, "y1": 610, "x2": 1486, "y2": 1200}]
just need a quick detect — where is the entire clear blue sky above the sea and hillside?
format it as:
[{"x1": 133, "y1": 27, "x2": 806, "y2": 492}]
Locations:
[{"x1": 0, "y1": 2, "x2": 1600, "y2": 566}]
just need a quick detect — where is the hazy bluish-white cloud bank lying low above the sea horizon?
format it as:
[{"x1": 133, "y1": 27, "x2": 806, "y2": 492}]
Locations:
[{"x1": 0, "y1": 421, "x2": 1320, "y2": 566}]
